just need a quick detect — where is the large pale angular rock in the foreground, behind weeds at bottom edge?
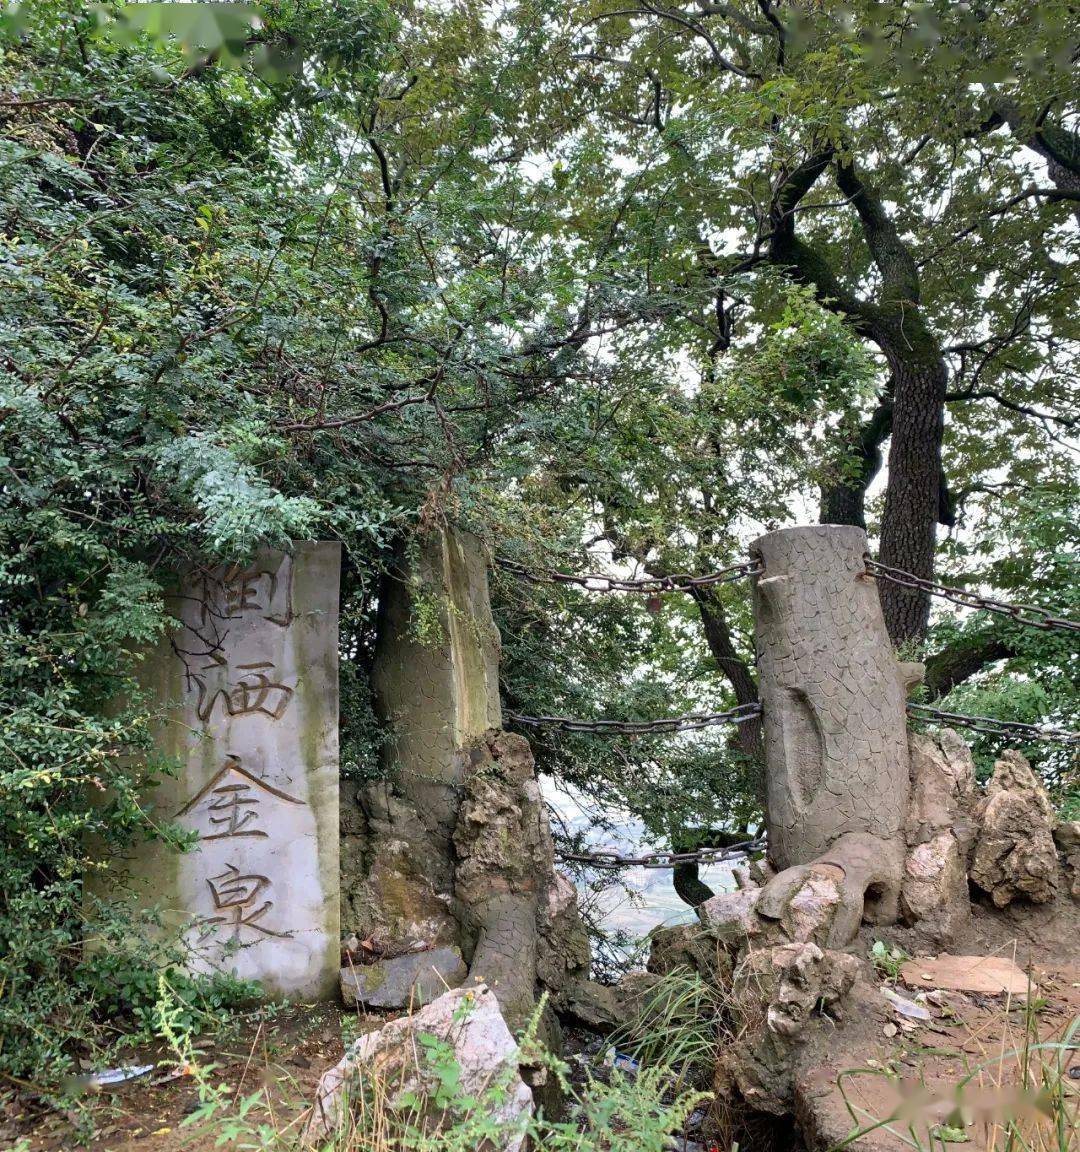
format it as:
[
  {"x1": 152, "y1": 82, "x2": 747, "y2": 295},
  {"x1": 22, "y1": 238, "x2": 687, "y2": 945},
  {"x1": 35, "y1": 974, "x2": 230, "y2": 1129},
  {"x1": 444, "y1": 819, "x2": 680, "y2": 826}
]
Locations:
[{"x1": 305, "y1": 984, "x2": 533, "y2": 1152}]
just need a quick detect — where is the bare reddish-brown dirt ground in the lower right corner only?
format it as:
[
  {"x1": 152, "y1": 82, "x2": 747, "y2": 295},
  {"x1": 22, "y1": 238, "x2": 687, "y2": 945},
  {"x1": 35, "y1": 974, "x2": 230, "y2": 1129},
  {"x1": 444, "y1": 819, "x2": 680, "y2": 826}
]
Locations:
[{"x1": 797, "y1": 946, "x2": 1080, "y2": 1152}]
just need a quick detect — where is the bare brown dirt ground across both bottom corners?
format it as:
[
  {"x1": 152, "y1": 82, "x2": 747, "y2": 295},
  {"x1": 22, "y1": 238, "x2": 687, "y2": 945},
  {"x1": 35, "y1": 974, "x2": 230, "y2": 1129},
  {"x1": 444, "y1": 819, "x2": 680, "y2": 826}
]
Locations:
[{"x1": 8, "y1": 918, "x2": 1080, "y2": 1152}]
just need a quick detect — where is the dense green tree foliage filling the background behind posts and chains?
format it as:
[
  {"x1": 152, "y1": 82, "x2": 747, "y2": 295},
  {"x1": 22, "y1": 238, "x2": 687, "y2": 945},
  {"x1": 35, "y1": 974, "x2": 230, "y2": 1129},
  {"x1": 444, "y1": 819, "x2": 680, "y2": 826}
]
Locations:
[{"x1": 0, "y1": 0, "x2": 1080, "y2": 1079}]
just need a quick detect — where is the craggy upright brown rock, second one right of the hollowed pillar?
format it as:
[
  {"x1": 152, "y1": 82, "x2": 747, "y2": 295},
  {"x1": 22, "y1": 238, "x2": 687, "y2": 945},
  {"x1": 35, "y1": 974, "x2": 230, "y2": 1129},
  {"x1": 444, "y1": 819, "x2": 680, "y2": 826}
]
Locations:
[{"x1": 969, "y1": 751, "x2": 1060, "y2": 908}]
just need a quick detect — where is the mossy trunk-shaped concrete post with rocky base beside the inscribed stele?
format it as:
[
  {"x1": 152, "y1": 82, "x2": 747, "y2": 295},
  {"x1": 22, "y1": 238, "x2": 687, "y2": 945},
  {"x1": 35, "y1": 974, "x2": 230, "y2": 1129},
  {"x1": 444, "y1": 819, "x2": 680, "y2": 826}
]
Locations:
[{"x1": 343, "y1": 528, "x2": 588, "y2": 1028}]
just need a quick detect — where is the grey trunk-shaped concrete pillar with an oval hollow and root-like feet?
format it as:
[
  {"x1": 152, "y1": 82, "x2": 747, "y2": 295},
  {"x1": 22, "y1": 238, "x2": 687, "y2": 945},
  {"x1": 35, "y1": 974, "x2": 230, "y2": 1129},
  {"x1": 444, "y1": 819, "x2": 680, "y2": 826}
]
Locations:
[{"x1": 752, "y1": 525, "x2": 922, "y2": 931}]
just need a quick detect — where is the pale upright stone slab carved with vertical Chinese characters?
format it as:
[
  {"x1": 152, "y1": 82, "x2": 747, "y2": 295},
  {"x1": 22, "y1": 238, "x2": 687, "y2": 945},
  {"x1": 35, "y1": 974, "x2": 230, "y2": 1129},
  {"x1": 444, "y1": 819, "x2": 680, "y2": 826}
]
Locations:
[{"x1": 113, "y1": 543, "x2": 341, "y2": 999}]
